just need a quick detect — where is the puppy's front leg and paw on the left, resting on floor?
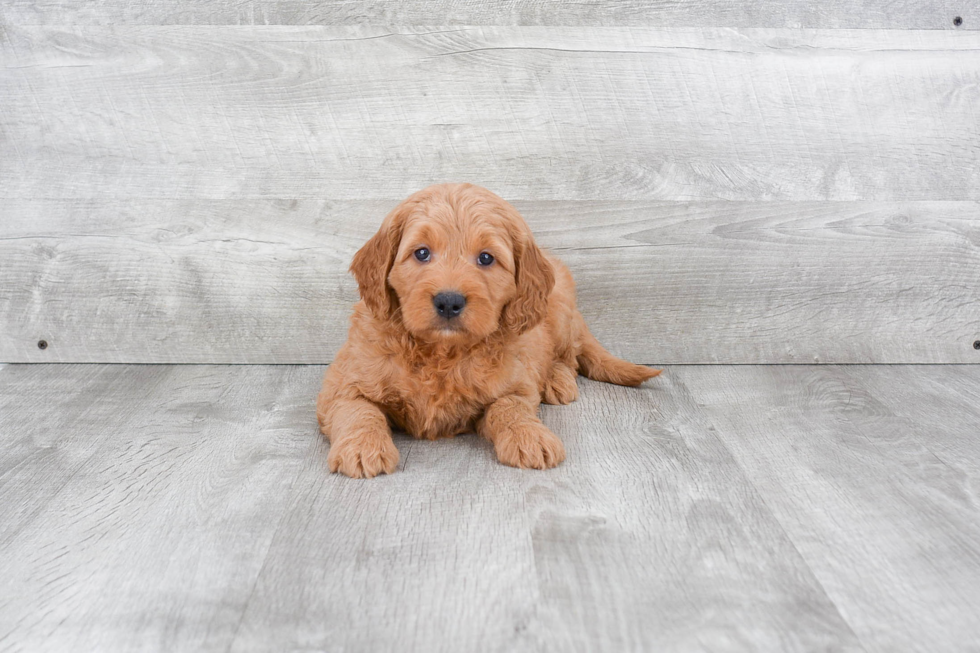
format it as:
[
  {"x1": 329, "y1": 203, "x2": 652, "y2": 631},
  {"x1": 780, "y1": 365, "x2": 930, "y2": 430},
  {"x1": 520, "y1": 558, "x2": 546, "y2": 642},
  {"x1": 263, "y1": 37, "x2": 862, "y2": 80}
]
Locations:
[{"x1": 317, "y1": 399, "x2": 398, "y2": 478}]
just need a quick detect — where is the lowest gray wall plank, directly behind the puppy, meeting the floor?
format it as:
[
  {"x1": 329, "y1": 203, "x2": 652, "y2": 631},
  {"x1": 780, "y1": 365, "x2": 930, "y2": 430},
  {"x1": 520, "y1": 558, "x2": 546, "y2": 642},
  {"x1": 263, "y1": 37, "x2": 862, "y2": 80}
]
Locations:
[{"x1": 0, "y1": 200, "x2": 980, "y2": 364}]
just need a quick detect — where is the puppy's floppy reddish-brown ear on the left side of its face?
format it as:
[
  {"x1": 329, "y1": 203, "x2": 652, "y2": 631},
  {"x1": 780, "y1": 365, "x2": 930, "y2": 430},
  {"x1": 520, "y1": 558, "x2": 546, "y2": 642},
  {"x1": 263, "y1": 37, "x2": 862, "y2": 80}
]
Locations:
[{"x1": 350, "y1": 202, "x2": 409, "y2": 320}]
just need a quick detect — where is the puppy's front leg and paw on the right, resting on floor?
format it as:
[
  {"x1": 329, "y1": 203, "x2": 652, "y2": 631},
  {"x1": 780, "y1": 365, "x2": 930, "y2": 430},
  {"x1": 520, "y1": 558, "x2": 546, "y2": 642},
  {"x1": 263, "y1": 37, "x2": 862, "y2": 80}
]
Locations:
[{"x1": 477, "y1": 395, "x2": 565, "y2": 469}]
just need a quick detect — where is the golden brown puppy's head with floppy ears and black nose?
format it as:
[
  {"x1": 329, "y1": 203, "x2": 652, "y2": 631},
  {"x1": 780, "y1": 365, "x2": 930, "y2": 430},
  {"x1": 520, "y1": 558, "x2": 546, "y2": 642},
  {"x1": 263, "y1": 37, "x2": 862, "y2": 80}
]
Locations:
[{"x1": 351, "y1": 184, "x2": 555, "y2": 343}]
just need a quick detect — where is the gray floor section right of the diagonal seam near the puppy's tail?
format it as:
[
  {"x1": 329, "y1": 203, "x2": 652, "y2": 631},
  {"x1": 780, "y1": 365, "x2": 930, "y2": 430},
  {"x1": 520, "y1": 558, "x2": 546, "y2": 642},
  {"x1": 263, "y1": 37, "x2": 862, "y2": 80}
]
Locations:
[{"x1": 674, "y1": 365, "x2": 980, "y2": 651}]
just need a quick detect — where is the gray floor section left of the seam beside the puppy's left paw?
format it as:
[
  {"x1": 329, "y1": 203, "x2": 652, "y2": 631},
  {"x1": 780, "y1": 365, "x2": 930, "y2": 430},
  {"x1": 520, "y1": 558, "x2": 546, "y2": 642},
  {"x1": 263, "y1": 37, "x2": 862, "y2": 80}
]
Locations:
[{"x1": 0, "y1": 365, "x2": 320, "y2": 651}]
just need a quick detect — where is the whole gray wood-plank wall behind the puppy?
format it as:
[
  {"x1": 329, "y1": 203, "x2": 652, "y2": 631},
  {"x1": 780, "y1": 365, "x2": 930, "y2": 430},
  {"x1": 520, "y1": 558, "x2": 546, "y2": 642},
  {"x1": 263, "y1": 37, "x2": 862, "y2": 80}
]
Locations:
[{"x1": 0, "y1": 0, "x2": 980, "y2": 364}]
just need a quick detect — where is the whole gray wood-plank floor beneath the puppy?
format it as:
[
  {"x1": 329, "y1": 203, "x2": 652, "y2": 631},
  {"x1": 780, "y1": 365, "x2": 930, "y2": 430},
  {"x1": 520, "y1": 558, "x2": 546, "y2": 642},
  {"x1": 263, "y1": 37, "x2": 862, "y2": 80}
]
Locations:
[{"x1": 0, "y1": 365, "x2": 980, "y2": 652}]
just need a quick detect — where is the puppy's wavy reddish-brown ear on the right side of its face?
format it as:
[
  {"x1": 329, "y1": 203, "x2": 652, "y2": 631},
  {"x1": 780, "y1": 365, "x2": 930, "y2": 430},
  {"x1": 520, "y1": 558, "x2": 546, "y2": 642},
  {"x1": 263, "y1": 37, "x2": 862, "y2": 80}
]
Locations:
[{"x1": 502, "y1": 232, "x2": 555, "y2": 334}]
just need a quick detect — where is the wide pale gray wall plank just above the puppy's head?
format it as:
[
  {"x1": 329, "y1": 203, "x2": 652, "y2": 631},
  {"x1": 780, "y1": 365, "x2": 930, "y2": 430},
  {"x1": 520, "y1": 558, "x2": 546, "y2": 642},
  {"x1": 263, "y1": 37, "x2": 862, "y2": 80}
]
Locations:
[{"x1": 0, "y1": 25, "x2": 980, "y2": 201}]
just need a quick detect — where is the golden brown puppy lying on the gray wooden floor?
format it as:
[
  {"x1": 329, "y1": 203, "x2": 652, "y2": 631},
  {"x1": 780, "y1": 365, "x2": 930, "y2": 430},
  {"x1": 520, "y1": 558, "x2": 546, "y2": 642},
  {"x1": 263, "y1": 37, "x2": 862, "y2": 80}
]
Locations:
[{"x1": 317, "y1": 184, "x2": 660, "y2": 478}]
